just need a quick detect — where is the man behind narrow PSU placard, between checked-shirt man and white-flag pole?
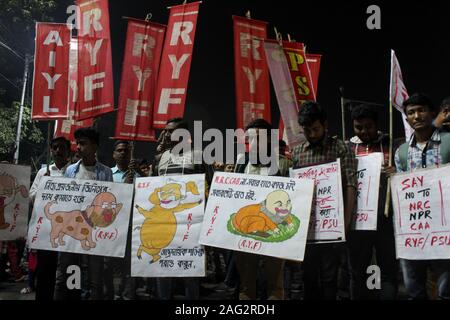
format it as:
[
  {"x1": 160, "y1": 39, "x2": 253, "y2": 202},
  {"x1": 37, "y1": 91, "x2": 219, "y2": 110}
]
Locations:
[{"x1": 347, "y1": 105, "x2": 398, "y2": 300}]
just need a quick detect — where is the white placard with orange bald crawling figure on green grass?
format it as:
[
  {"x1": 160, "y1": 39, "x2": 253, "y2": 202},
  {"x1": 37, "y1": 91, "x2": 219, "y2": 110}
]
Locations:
[{"x1": 200, "y1": 172, "x2": 314, "y2": 261}]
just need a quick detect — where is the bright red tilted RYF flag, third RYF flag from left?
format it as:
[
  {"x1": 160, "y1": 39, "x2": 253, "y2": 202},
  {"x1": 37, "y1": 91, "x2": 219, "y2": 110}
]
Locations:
[{"x1": 153, "y1": 2, "x2": 200, "y2": 129}]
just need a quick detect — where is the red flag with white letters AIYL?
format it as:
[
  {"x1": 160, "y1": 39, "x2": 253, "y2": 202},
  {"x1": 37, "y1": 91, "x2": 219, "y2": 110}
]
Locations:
[{"x1": 31, "y1": 22, "x2": 70, "y2": 120}]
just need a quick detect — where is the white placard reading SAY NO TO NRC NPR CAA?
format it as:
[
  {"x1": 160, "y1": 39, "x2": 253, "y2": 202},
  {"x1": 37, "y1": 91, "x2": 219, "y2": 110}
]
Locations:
[{"x1": 391, "y1": 166, "x2": 450, "y2": 260}]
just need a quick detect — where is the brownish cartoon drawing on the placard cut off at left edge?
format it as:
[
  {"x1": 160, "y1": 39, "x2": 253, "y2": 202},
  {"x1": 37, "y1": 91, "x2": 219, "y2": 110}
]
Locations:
[{"x1": 0, "y1": 173, "x2": 28, "y2": 230}]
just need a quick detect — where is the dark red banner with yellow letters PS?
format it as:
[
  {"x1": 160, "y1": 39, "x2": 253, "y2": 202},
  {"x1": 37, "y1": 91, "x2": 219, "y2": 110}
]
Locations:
[{"x1": 283, "y1": 41, "x2": 316, "y2": 108}]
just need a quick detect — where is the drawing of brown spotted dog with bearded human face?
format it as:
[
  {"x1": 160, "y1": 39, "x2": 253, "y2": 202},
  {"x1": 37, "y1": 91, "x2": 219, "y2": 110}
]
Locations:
[{"x1": 44, "y1": 192, "x2": 123, "y2": 251}]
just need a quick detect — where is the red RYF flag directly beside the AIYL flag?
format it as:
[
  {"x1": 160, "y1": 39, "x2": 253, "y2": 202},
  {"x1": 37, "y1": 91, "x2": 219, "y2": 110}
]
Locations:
[{"x1": 75, "y1": 0, "x2": 114, "y2": 120}]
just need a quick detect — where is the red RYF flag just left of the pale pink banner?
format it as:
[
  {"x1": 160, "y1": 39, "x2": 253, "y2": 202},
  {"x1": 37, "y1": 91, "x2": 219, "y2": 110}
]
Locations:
[{"x1": 233, "y1": 16, "x2": 270, "y2": 129}]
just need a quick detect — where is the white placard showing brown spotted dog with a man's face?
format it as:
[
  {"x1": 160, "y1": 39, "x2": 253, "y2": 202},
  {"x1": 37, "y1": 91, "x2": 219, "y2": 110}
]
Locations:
[{"x1": 28, "y1": 177, "x2": 133, "y2": 257}]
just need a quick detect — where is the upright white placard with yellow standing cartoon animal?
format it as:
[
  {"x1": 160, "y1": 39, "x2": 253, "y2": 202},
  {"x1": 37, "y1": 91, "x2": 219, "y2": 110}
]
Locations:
[{"x1": 131, "y1": 174, "x2": 206, "y2": 277}]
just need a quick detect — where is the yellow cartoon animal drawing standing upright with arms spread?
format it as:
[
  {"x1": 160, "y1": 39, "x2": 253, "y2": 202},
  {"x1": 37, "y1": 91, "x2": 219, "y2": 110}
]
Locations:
[{"x1": 136, "y1": 181, "x2": 202, "y2": 263}]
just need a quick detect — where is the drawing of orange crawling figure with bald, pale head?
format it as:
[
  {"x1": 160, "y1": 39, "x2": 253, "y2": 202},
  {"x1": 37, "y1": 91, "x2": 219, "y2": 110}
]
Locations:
[{"x1": 232, "y1": 190, "x2": 294, "y2": 237}]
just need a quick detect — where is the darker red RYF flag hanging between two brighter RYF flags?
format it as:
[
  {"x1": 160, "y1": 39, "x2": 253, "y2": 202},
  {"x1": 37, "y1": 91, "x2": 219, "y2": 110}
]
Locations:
[{"x1": 115, "y1": 19, "x2": 166, "y2": 141}]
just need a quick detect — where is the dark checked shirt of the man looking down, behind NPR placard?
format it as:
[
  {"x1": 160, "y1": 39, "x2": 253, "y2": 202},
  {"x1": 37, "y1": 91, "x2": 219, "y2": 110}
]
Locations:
[{"x1": 292, "y1": 137, "x2": 357, "y2": 188}]
